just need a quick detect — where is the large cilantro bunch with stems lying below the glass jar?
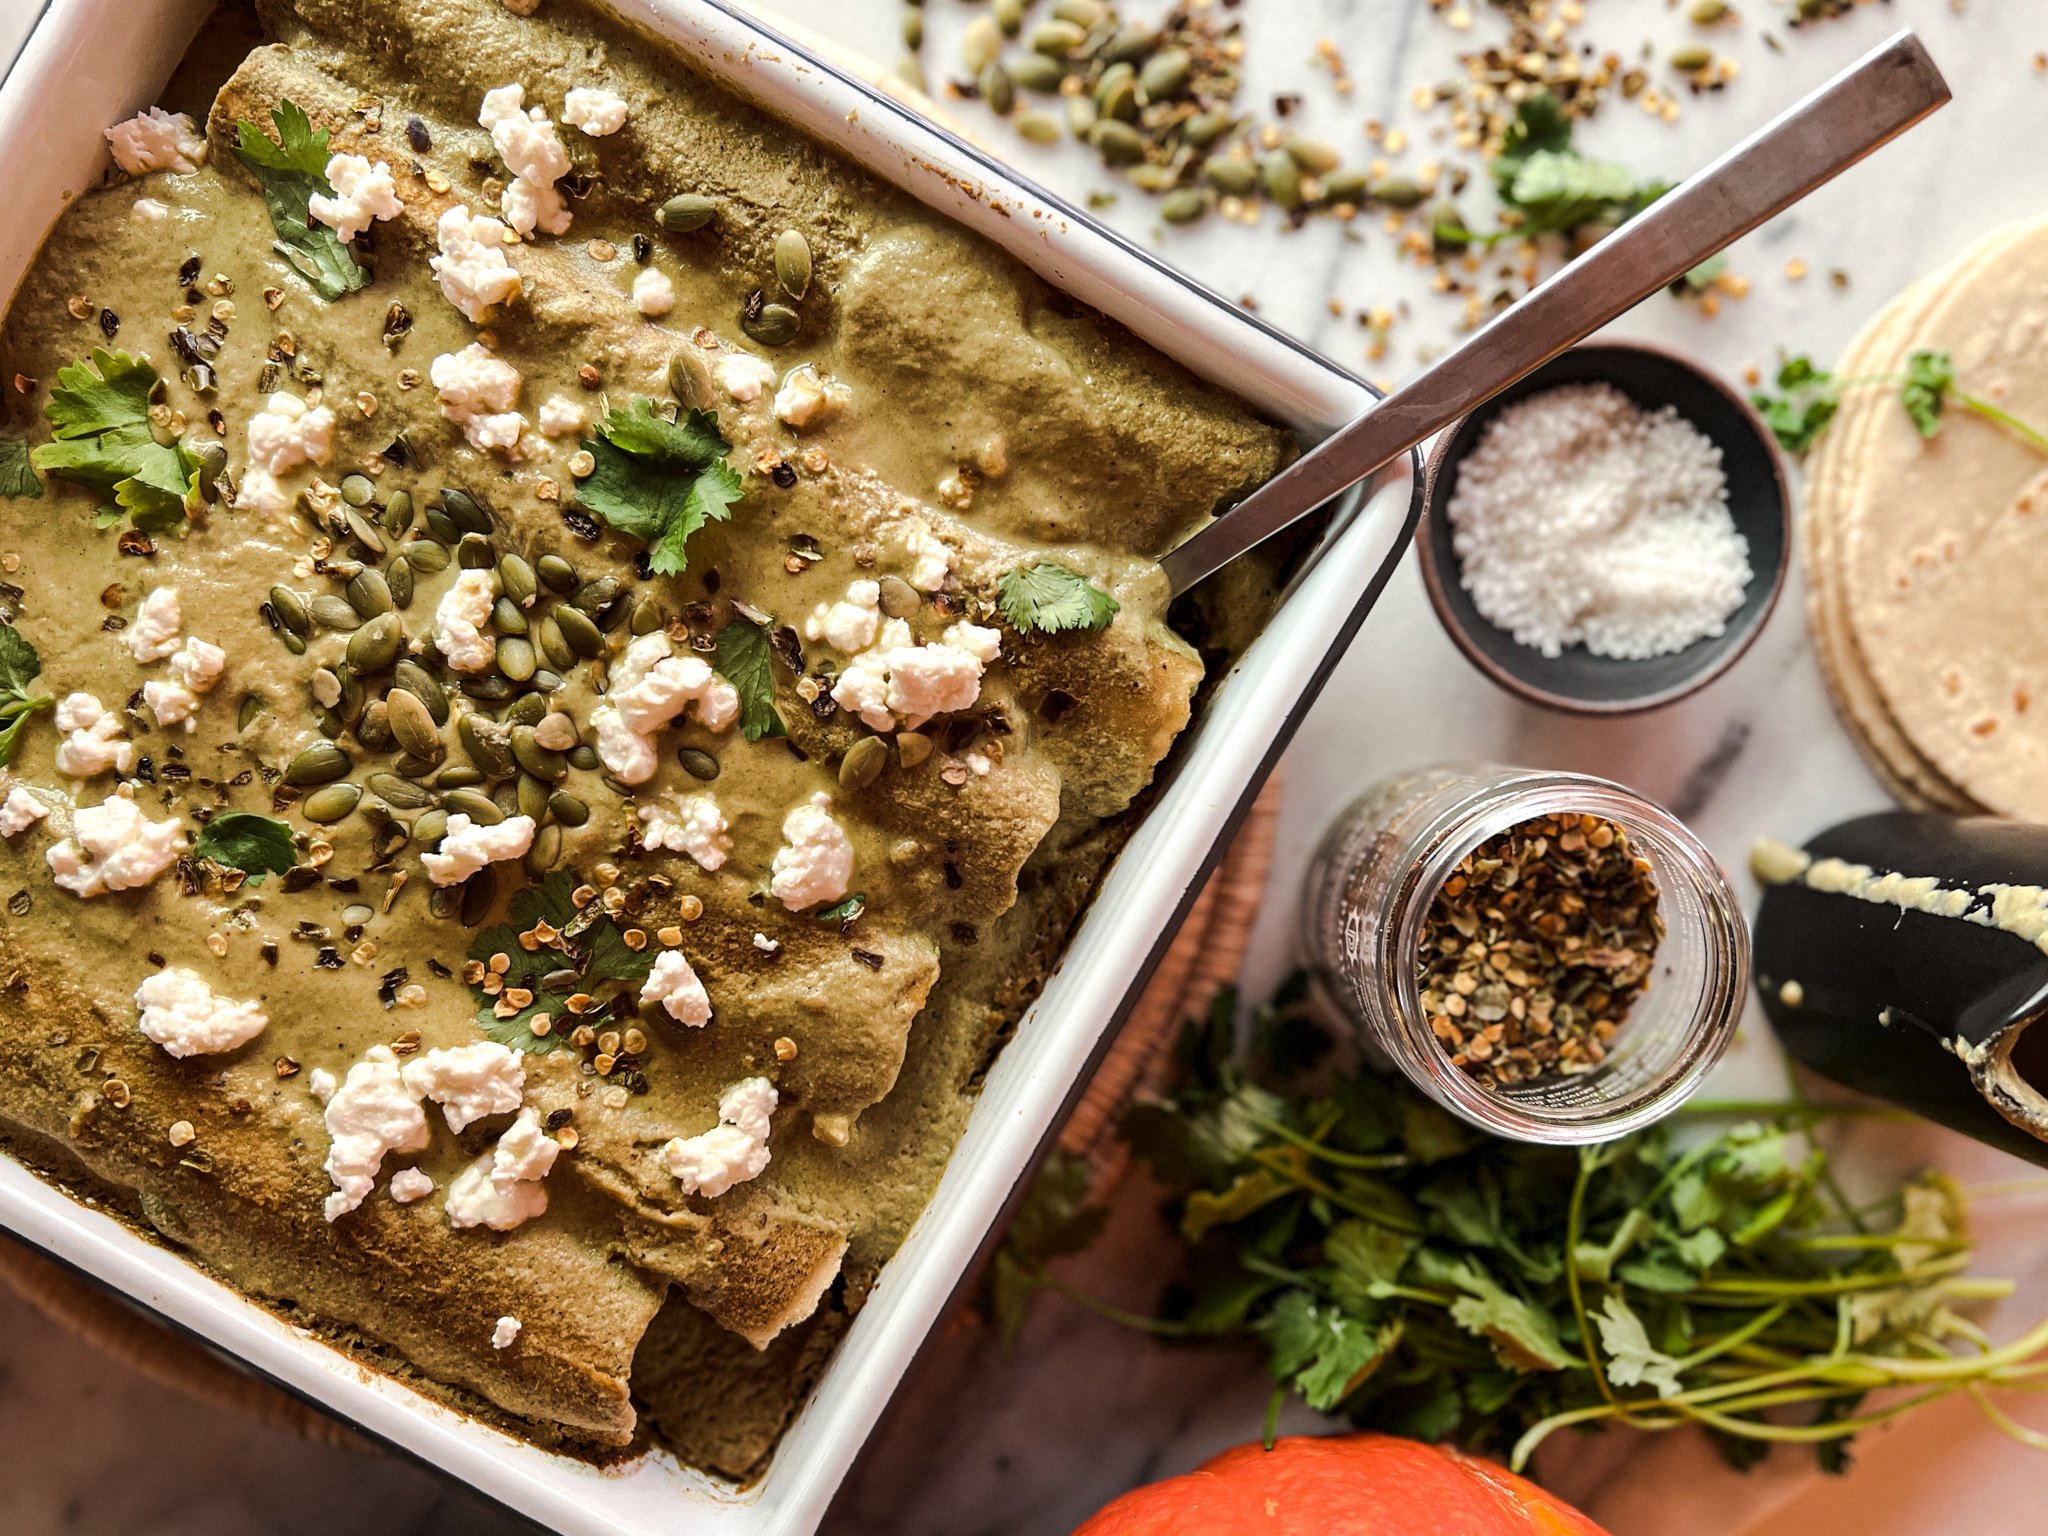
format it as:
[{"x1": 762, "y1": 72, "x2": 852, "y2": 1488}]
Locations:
[{"x1": 993, "y1": 979, "x2": 2048, "y2": 1470}]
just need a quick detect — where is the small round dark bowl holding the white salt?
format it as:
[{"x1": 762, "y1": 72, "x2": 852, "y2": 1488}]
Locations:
[{"x1": 1421, "y1": 342, "x2": 1792, "y2": 715}]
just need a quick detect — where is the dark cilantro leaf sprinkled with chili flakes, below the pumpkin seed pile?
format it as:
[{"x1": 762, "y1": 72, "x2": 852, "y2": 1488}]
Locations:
[{"x1": 469, "y1": 870, "x2": 653, "y2": 1057}]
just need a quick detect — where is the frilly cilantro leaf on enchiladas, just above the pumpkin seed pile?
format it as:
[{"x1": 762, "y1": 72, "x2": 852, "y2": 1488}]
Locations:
[{"x1": 575, "y1": 395, "x2": 743, "y2": 575}]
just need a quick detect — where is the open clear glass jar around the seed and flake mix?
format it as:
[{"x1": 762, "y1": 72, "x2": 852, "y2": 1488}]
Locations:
[{"x1": 1305, "y1": 766, "x2": 1749, "y2": 1145}]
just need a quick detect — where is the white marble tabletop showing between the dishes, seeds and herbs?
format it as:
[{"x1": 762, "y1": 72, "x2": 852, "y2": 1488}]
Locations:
[{"x1": 12, "y1": 0, "x2": 2048, "y2": 1536}]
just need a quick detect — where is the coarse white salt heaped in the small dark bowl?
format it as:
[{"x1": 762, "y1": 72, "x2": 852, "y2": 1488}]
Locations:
[{"x1": 1446, "y1": 383, "x2": 1751, "y2": 659}]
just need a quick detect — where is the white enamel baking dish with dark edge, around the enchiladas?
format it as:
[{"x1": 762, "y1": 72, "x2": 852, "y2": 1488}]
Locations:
[{"x1": 0, "y1": 0, "x2": 1419, "y2": 1536}]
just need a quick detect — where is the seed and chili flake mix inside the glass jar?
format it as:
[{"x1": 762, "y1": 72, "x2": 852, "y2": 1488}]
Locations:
[{"x1": 1415, "y1": 815, "x2": 1665, "y2": 1087}]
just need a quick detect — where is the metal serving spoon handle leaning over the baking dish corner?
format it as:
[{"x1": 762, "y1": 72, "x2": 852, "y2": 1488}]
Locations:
[{"x1": 1159, "y1": 33, "x2": 1950, "y2": 592}]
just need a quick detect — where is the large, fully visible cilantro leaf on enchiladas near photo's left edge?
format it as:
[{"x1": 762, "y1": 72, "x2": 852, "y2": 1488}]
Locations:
[{"x1": 29, "y1": 346, "x2": 199, "y2": 532}]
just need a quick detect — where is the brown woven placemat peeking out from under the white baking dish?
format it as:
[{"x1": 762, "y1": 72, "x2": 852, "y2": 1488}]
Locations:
[{"x1": 0, "y1": 784, "x2": 1278, "y2": 1450}]
